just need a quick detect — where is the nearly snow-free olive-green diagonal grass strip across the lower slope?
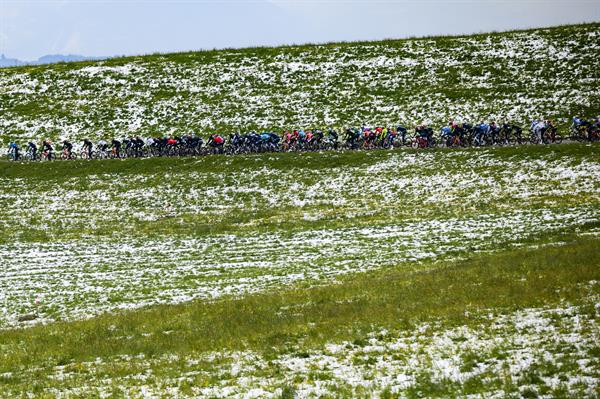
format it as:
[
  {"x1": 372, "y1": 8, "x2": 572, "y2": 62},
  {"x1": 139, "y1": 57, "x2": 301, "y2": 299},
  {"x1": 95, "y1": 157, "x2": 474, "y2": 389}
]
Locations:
[{"x1": 0, "y1": 233, "x2": 600, "y2": 372}]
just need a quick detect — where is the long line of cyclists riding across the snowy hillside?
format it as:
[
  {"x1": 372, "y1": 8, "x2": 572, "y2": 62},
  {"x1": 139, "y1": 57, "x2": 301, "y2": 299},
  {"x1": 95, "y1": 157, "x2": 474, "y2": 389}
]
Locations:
[{"x1": 4, "y1": 117, "x2": 600, "y2": 160}]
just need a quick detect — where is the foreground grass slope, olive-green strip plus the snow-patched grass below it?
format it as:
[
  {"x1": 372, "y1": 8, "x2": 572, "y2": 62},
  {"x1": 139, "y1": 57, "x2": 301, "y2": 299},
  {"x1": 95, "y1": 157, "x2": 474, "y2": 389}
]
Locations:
[{"x1": 0, "y1": 237, "x2": 600, "y2": 397}]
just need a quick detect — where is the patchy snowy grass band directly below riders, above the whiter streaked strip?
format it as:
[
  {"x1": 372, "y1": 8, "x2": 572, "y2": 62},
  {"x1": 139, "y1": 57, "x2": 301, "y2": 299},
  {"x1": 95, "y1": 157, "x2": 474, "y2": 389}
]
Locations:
[{"x1": 0, "y1": 144, "x2": 599, "y2": 243}]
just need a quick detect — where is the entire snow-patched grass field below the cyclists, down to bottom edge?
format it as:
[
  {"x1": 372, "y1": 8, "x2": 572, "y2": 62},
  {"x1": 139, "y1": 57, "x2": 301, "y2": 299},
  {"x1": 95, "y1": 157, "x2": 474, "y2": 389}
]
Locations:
[{"x1": 0, "y1": 144, "x2": 600, "y2": 397}]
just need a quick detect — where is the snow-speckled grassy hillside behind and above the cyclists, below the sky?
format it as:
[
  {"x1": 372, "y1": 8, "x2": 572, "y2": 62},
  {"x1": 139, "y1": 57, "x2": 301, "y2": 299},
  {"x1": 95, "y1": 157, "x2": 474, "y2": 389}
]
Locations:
[{"x1": 0, "y1": 23, "x2": 600, "y2": 143}]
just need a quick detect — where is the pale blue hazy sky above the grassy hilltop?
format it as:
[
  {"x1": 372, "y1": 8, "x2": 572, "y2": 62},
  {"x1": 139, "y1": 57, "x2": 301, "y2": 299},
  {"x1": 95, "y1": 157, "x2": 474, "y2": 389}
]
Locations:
[{"x1": 0, "y1": 0, "x2": 600, "y2": 60}]
